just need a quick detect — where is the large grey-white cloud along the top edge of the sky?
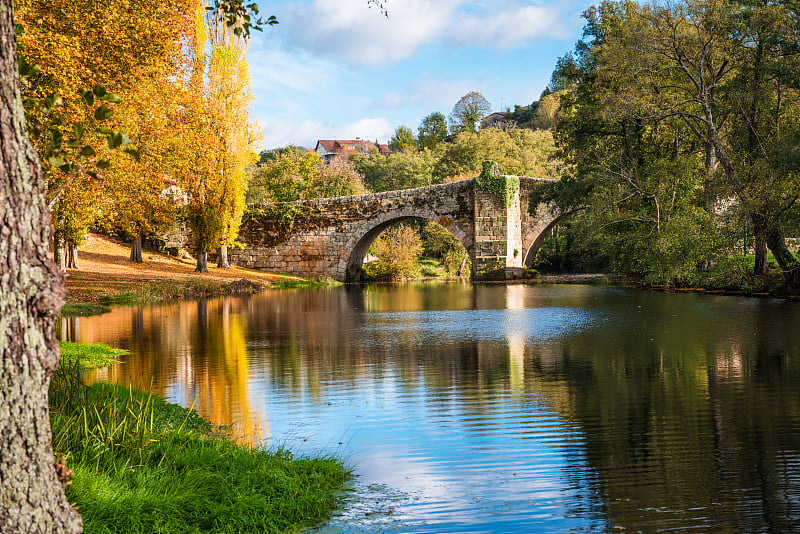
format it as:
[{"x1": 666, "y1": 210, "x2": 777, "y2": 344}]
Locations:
[{"x1": 281, "y1": 0, "x2": 568, "y2": 67}]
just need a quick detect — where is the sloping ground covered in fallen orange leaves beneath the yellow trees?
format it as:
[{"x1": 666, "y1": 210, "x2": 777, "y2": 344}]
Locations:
[{"x1": 61, "y1": 234, "x2": 303, "y2": 303}]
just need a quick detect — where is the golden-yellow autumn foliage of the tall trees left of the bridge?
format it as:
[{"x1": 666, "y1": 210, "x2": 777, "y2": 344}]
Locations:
[{"x1": 15, "y1": 0, "x2": 255, "y2": 267}]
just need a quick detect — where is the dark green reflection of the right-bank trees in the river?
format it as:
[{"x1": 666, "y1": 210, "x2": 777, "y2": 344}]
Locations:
[{"x1": 530, "y1": 296, "x2": 800, "y2": 532}]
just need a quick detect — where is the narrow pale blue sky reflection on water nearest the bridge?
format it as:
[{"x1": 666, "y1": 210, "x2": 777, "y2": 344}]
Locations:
[{"x1": 367, "y1": 308, "x2": 596, "y2": 342}]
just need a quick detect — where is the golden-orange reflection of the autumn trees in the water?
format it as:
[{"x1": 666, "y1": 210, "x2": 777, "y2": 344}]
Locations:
[{"x1": 82, "y1": 298, "x2": 260, "y2": 441}]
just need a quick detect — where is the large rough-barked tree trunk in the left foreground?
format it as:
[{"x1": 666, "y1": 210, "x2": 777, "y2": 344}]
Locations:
[{"x1": 0, "y1": 0, "x2": 81, "y2": 533}]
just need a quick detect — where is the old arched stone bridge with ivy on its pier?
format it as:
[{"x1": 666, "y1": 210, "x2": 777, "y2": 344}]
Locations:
[{"x1": 230, "y1": 177, "x2": 558, "y2": 281}]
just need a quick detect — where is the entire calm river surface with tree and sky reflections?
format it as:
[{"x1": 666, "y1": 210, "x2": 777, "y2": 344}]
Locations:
[{"x1": 61, "y1": 284, "x2": 800, "y2": 533}]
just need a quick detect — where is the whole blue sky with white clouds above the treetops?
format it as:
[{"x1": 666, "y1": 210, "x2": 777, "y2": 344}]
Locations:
[{"x1": 248, "y1": 0, "x2": 592, "y2": 148}]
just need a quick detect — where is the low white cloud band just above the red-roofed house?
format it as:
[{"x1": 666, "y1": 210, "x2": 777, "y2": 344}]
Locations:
[{"x1": 259, "y1": 117, "x2": 394, "y2": 148}]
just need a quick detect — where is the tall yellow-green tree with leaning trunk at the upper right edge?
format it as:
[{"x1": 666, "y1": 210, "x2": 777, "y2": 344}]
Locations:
[{"x1": 592, "y1": 0, "x2": 800, "y2": 292}]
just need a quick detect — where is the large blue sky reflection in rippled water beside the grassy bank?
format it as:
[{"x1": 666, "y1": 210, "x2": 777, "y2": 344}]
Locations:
[{"x1": 271, "y1": 382, "x2": 588, "y2": 532}]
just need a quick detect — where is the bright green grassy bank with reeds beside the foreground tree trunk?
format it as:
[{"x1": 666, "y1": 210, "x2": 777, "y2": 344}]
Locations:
[{"x1": 50, "y1": 344, "x2": 349, "y2": 533}]
